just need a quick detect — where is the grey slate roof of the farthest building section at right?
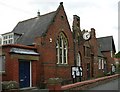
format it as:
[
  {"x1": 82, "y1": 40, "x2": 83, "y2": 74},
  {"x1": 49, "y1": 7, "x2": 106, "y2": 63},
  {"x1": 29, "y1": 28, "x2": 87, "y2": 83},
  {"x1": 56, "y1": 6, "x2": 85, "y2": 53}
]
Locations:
[{"x1": 97, "y1": 36, "x2": 116, "y2": 52}]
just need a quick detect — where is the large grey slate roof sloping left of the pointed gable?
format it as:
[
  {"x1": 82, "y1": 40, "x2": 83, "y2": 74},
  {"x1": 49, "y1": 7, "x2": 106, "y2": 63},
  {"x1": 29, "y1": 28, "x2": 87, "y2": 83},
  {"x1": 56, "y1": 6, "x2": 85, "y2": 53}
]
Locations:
[{"x1": 12, "y1": 12, "x2": 56, "y2": 45}]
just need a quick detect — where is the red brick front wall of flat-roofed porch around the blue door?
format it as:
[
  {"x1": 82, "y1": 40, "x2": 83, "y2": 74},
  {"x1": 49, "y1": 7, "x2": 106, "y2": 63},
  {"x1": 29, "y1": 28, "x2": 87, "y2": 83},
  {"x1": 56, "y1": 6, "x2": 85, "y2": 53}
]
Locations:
[{"x1": 2, "y1": 46, "x2": 41, "y2": 86}]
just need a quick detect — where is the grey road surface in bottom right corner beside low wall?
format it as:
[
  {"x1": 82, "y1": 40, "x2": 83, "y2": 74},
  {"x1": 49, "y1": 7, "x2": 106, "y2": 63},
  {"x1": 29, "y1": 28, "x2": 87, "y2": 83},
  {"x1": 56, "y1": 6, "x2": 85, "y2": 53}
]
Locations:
[{"x1": 88, "y1": 78, "x2": 120, "y2": 92}]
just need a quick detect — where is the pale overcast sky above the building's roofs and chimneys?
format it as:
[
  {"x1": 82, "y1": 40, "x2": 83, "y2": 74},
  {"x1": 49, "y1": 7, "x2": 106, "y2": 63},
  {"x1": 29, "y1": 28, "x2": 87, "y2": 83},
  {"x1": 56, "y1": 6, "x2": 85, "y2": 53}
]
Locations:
[{"x1": 0, "y1": 0, "x2": 120, "y2": 52}]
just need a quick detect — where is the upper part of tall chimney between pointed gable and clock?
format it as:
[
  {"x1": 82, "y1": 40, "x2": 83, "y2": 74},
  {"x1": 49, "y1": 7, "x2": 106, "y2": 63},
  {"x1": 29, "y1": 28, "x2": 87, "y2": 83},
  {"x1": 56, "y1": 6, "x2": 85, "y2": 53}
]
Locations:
[{"x1": 73, "y1": 15, "x2": 80, "y2": 31}]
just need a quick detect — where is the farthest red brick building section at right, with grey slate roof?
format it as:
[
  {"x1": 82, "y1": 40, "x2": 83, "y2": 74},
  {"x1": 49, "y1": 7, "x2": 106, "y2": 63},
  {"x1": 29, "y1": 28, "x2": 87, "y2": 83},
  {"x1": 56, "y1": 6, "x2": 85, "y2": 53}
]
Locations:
[{"x1": 97, "y1": 36, "x2": 116, "y2": 75}]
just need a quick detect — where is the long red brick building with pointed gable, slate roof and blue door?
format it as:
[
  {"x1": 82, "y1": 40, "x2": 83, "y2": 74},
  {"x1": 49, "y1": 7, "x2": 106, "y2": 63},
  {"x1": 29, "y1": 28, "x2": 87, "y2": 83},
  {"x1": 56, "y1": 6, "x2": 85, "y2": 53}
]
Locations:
[{"x1": 1, "y1": 2, "x2": 115, "y2": 88}]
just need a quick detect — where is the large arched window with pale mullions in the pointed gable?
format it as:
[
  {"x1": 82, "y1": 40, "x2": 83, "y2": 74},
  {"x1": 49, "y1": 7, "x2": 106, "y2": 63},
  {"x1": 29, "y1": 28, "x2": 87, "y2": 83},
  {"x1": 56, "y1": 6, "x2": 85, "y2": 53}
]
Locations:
[{"x1": 56, "y1": 33, "x2": 68, "y2": 64}]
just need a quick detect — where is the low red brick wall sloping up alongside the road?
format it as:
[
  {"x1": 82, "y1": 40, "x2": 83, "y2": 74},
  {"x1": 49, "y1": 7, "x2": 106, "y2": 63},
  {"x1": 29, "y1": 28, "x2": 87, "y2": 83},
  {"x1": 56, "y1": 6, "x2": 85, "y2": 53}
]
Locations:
[{"x1": 61, "y1": 74, "x2": 120, "y2": 91}]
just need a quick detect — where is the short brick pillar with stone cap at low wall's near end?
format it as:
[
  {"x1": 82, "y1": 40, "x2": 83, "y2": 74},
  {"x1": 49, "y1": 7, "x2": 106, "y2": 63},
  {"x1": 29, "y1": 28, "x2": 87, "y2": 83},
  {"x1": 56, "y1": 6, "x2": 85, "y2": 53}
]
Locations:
[{"x1": 47, "y1": 78, "x2": 62, "y2": 92}]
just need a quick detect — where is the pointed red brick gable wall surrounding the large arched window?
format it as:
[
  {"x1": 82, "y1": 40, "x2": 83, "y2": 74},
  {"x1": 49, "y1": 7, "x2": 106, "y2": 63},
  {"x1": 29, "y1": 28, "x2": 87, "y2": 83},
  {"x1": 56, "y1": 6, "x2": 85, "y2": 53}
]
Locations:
[{"x1": 35, "y1": 5, "x2": 74, "y2": 85}]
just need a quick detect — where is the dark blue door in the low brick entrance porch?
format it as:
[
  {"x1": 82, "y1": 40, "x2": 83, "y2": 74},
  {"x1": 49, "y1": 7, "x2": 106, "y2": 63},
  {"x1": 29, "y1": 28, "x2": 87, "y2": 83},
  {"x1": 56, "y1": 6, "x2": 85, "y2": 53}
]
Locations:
[{"x1": 19, "y1": 60, "x2": 30, "y2": 88}]
